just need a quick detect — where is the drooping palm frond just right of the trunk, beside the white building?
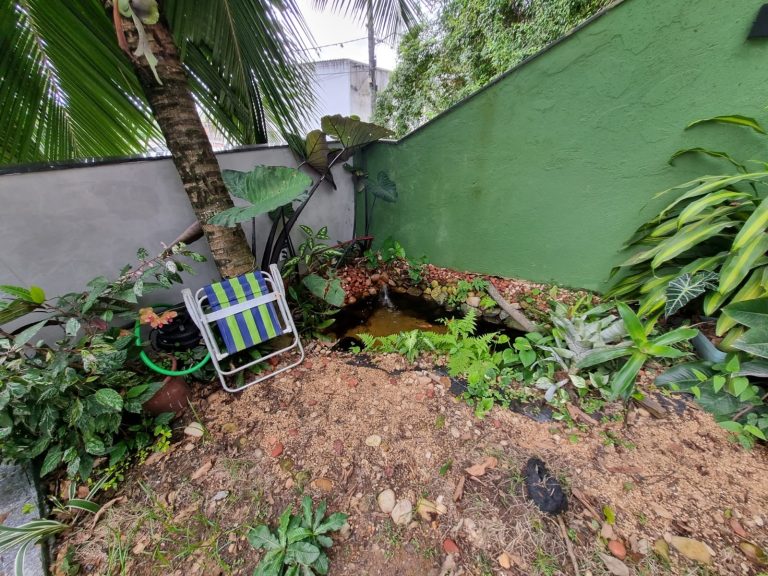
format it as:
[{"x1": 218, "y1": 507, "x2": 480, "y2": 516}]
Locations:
[{"x1": 163, "y1": 0, "x2": 312, "y2": 144}]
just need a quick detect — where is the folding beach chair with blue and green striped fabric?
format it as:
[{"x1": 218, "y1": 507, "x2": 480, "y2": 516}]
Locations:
[{"x1": 181, "y1": 264, "x2": 304, "y2": 392}]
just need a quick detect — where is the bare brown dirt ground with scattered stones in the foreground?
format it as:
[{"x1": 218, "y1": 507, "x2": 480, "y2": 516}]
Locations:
[{"x1": 54, "y1": 344, "x2": 768, "y2": 576}]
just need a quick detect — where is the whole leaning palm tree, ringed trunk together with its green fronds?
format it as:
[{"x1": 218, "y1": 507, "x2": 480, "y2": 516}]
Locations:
[{"x1": 0, "y1": 0, "x2": 417, "y2": 277}]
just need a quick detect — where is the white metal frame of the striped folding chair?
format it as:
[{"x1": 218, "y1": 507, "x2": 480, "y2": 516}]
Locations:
[{"x1": 181, "y1": 264, "x2": 304, "y2": 392}]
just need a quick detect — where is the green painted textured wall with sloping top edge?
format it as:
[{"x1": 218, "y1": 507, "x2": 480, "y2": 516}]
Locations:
[{"x1": 358, "y1": 0, "x2": 768, "y2": 290}]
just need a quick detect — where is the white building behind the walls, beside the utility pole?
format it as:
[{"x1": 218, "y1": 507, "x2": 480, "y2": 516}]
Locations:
[{"x1": 306, "y1": 58, "x2": 390, "y2": 131}]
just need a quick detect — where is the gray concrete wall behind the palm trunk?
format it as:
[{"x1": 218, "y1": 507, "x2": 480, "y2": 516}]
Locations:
[{"x1": 0, "y1": 146, "x2": 354, "y2": 301}]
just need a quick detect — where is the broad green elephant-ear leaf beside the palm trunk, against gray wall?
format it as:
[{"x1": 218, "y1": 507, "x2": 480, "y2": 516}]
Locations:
[{"x1": 208, "y1": 166, "x2": 312, "y2": 227}]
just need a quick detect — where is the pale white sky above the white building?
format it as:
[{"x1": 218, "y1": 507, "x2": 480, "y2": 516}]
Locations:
[{"x1": 297, "y1": 0, "x2": 397, "y2": 70}]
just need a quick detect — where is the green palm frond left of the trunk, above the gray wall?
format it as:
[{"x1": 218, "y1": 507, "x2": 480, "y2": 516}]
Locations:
[{"x1": 0, "y1": 0, "x2": 162, "y2": 164}]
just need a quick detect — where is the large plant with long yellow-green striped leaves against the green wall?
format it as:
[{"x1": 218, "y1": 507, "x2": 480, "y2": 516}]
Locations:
[{"x1": 606, "y1": 116, "x2": 768, "y2": 344}]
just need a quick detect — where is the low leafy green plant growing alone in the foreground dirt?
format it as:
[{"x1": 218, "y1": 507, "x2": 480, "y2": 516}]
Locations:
[{"x1": 248, "y1": 496, "x2": 348, "y2": 576}]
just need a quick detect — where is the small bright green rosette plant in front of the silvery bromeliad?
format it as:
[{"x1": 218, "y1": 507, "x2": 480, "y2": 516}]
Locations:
[{"x1": 576, "y1": 302, "x2": 699, "y2": 401}]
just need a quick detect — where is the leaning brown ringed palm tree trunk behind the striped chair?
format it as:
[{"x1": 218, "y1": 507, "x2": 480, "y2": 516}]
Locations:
[{"x1": 121, "y1": 19, "x2": 255, "y2": 278}]
